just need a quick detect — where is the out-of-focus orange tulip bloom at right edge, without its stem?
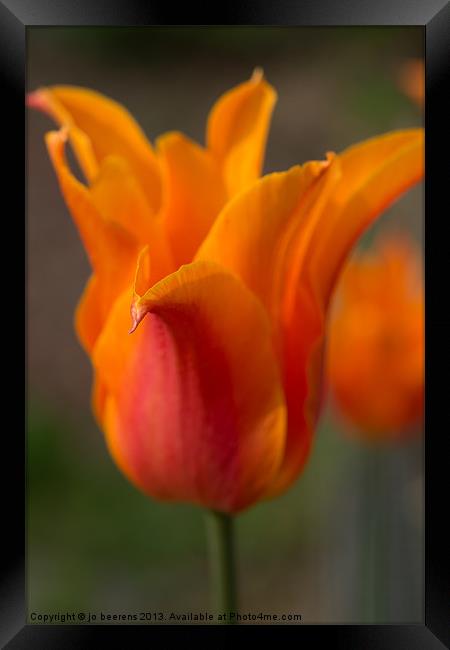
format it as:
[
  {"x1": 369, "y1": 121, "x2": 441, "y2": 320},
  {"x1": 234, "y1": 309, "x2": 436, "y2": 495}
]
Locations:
[{"x1": 328, "y1": 230, "x2": 424, "y2": 440}]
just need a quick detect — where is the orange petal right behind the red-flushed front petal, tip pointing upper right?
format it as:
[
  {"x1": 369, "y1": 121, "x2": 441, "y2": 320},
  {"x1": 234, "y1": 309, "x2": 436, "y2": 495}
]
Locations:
[{"x1": 196, "y1": 161, "x2": 336, "y2": 327}]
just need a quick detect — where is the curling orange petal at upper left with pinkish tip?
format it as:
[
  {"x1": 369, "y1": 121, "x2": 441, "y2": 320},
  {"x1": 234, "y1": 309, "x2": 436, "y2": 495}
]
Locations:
[{"x1": 28, "y1": 86, "x2": 161, "y2": 212}]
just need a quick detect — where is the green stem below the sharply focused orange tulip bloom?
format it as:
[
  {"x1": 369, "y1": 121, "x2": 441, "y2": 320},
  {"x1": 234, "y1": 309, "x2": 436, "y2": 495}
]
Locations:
[{"x1": 207, "y1": 510, "x2": 237, "y2": 624}]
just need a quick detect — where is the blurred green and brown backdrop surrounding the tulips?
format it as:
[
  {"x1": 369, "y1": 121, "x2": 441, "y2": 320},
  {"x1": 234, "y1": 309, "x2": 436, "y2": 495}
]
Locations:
[{"x1": 27, "y1": 27, "x2": 423, "y2": 623}]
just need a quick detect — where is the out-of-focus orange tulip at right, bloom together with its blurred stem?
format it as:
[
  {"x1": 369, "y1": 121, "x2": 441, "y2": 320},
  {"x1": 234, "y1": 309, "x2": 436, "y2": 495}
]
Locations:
[{"x1": 327, "y1": 234, "x2": 424, "y2": 622}]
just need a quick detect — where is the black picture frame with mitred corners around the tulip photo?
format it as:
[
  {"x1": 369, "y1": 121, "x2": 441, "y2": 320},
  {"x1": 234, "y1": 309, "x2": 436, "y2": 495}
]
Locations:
[{"x1": 4, "y1": 0, "x2": 450, "y2": 650}]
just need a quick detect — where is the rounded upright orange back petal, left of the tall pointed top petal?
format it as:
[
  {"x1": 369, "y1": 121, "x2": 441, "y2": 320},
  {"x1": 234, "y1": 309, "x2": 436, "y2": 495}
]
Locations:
[{"x1": 157, "y1": 133, "x2": 226, "y2": 268}]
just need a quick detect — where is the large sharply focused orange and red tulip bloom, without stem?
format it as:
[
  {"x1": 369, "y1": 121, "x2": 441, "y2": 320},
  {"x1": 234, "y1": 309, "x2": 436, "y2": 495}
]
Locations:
[{"x1": 29, "y1": 72, "x2": 423, "y2": 513}]
